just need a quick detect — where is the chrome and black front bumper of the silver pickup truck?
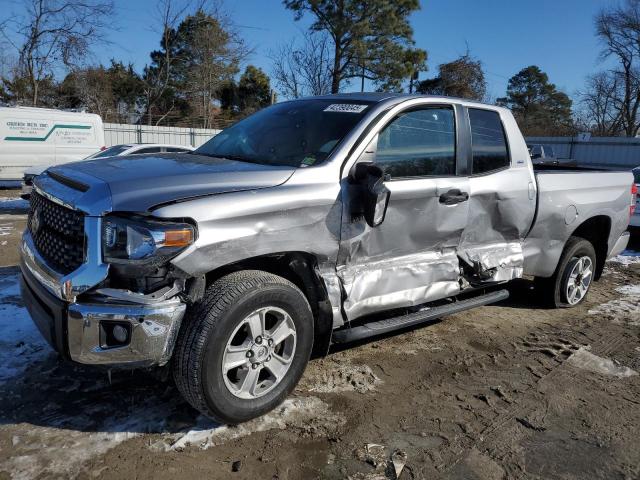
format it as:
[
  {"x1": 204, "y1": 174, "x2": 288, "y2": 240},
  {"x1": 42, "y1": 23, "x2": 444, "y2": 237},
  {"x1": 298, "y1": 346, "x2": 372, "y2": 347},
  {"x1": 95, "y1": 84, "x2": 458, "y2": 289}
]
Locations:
[{"x1": 20, "y1": 262, "x2": 186, "y2": 367}]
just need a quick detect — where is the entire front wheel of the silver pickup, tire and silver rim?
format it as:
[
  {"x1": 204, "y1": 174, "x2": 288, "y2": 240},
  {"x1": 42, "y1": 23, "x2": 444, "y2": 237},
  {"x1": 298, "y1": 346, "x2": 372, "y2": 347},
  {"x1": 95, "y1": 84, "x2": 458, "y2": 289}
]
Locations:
[{"x1": 174, "y1": 270, "x2": 313, "y2": 424}]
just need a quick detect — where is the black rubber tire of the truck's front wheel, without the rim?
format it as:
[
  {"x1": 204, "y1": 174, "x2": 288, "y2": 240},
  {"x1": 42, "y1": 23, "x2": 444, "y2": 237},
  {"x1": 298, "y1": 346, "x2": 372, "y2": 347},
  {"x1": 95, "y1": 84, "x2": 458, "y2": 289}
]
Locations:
[{"x1": 173, "y1": 270, "x2": 313, "y2": 424}]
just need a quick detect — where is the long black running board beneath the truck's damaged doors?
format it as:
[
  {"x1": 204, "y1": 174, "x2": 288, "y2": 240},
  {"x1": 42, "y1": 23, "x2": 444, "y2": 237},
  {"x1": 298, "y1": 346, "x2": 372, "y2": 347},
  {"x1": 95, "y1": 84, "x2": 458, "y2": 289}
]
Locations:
[{"x1": 331, "y1": 290, "x2": 509, "y2": 343}]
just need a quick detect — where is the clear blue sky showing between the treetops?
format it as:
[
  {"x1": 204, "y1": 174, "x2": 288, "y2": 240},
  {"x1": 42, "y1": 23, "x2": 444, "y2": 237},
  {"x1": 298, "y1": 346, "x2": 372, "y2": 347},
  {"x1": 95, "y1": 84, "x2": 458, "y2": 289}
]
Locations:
[{"x1": 0, "y1": 0, "x2": 615, "y2": 101}]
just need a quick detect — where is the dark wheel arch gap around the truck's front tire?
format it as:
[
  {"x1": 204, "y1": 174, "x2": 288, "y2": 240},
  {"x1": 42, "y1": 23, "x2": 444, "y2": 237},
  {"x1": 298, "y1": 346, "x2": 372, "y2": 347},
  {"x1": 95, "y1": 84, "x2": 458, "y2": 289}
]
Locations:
[{"x1": 205, "y1": 251, "x2": 333, "y2": 358}]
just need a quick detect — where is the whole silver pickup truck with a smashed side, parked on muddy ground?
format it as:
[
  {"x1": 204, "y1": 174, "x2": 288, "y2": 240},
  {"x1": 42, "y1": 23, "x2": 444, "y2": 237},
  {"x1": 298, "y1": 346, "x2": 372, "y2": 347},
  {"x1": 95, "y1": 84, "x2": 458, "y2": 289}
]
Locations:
[{"x1": 21, "y1": 93, "x2": 635, "y2": 423}]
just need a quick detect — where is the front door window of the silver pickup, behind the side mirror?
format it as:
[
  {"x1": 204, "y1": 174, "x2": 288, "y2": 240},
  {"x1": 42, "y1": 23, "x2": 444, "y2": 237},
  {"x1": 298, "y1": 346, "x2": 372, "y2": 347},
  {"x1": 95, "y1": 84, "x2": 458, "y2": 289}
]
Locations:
[{"x1": 376, "y1": 108, "x2": 456, "y2": 179}]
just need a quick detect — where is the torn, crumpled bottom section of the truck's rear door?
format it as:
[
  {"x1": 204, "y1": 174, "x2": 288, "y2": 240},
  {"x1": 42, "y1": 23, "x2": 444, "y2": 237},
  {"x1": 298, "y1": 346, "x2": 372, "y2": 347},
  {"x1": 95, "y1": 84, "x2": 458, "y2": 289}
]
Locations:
[{"x1": 459, "y1": 241, "x2": 524, "y2": 282}]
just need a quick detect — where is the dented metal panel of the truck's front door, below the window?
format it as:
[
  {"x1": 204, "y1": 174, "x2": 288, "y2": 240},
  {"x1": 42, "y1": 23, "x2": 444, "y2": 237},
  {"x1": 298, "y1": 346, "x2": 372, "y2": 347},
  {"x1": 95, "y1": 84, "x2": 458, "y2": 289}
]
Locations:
[{"x1": 337, "y1": 177, "x2": 467, "y2": 320}]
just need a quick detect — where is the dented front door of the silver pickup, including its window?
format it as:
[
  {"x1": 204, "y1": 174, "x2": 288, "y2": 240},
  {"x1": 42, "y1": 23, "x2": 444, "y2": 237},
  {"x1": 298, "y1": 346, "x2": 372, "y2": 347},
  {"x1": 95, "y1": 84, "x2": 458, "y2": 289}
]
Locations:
[{"x1": 337, "y1": 104, "x2": 469, "y2": 320}]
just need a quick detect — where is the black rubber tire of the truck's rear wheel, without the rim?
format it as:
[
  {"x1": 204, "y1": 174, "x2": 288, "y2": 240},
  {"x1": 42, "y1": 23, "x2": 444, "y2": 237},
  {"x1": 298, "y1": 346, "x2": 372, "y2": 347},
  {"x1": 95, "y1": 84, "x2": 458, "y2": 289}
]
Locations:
[{"x1": 535, "y1": 237, "x2": 596, "y2": 308}]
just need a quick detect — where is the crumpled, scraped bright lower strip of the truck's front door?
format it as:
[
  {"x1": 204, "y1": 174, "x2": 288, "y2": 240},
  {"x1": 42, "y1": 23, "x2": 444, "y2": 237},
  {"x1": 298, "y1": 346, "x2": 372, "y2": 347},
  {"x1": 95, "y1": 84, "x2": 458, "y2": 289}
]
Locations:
[{"x1": 338, "y1": 250, "x2": 460, "y2": 320}]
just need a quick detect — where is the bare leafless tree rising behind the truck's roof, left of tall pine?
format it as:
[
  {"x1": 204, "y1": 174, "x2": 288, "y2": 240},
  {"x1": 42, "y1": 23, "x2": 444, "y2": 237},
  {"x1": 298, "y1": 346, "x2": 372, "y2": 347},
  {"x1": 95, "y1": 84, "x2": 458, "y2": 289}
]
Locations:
[{"x1": 269, "y1": 33, "x2": 333, "y2": 98}]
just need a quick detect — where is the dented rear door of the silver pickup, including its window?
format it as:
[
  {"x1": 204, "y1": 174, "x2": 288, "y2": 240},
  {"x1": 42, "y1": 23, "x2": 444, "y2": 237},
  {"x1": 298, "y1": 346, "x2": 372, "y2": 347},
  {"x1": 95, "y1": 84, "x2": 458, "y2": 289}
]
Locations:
[{"x1": 459, "y1": 108, "x2": 536, "y2": 283}]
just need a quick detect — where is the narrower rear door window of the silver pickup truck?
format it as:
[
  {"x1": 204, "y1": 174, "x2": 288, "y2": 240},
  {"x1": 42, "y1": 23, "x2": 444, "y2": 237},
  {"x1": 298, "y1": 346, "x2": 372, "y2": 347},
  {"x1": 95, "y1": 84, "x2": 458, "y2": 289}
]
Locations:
[{"x1": 469, "y1": 108, "x2": 510, "y2": 174}]
